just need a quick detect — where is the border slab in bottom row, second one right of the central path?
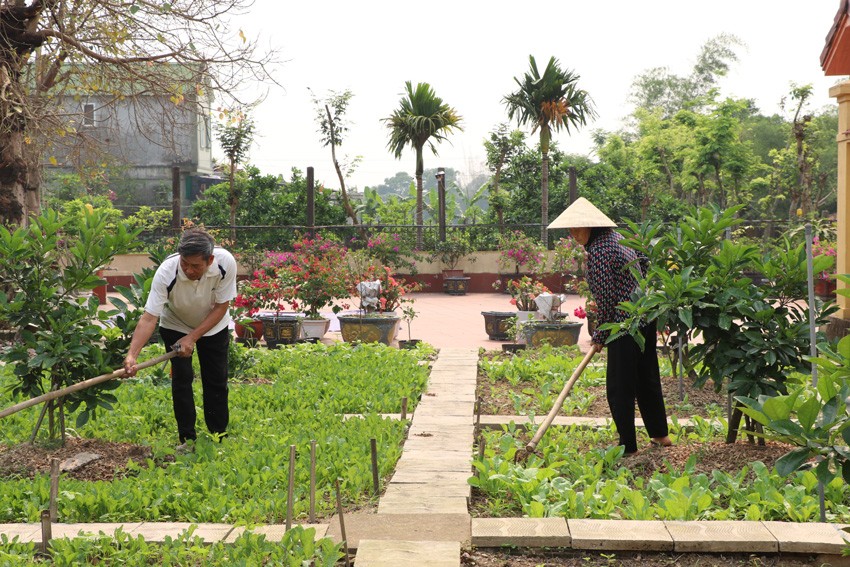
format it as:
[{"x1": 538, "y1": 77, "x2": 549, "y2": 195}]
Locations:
[{"x1": 567, "y1": 520, "x2": 674, "y2": 551}]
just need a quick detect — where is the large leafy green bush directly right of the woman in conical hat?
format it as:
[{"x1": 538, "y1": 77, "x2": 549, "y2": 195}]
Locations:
[{"x1": 607, "y1": 207, "x2": 831, "y2": 442}]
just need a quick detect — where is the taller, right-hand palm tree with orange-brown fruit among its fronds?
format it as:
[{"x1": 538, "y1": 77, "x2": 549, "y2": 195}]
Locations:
[{"x1": 503, "y1": 55, "x2": 596, "y2": 244}]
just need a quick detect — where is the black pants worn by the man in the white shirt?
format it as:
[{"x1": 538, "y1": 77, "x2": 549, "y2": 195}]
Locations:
[{"x1": 159, "y1": 327, "x2": 230, "y2": 443}]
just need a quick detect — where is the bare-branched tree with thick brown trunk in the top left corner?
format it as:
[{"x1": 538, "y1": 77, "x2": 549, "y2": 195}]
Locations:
[{"x1": 0, "y1": 0, "x2": 274, "y2": 224}]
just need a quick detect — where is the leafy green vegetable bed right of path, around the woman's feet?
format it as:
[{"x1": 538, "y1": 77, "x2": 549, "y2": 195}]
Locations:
[{"x1": 470, "y1": 349, "x2": 850, "y2": 522}]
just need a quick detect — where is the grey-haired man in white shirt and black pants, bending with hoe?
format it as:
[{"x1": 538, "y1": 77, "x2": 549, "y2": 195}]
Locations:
[{"x1": 124, "y1": 229, "x2": 236, "y2": 452}]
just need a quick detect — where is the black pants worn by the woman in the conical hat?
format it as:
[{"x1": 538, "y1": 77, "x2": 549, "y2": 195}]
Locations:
[{"x1": 606, "y1": 323, "x2": 668, "y2": 453}]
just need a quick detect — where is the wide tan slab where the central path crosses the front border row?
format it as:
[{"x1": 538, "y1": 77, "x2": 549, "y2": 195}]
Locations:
[{"x1": 327, "y1": 513, "x2": 471, "y2": 549}]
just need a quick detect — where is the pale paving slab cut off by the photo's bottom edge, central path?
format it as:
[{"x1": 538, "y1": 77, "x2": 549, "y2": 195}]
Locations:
[{"x1": 355, "y1": 540, "x2": 460, "y2": 567}]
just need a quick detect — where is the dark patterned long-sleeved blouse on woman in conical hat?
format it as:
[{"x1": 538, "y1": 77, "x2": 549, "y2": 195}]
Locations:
[{"x1": 586, "y1": 230, "x2": 645, "y2": 345}]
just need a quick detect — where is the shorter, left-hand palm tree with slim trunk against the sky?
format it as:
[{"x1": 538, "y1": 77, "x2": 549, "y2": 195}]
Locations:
[{"x1": 383, "y1": 81, "x2": 463, "y2": 248}]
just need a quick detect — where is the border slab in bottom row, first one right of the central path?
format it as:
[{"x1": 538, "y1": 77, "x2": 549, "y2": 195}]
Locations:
[{"x1": 472, "y1": 518, "x2": 572, "y2": 547}]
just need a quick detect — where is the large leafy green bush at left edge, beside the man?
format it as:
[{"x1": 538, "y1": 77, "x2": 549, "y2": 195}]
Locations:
[{"x1": 0, "y1": 211, "x2": 141, "y2": 437}]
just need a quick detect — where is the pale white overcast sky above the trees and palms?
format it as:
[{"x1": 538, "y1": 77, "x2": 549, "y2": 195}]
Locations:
[{"x1": 229, "y1": 0, "x2": 846, "y2": 189}]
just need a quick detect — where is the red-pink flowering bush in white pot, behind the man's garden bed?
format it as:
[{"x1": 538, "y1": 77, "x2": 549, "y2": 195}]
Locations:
[{"x1": 283, "y1": 236, "x2": 349, "y2": 338}]
